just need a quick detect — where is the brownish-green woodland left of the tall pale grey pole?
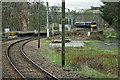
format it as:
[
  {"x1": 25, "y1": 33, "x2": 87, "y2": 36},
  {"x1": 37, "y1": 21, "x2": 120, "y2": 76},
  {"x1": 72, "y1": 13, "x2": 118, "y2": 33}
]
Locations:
[{"x1": 2, "y1": 2, "x2": 46, "y2": 31}]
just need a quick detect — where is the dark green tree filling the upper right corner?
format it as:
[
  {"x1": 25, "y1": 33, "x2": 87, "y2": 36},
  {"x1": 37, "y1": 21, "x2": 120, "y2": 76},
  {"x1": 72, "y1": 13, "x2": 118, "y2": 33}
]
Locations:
[{"x1": 100, "y1": 2, "x2": 120, "y2": 31}]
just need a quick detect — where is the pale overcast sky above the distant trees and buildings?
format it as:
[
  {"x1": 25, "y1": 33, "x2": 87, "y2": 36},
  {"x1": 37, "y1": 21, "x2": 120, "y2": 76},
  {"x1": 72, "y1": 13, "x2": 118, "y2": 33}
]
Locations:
[{"x1": 43, "y1": 0, "x2": 102, "y2": 9}]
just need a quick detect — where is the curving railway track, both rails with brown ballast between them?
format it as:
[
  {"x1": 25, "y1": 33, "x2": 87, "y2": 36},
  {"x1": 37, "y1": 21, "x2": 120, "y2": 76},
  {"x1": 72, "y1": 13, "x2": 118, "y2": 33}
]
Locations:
[{"x1": 6, "y1": 38, "x2": 58, "y2": 80}]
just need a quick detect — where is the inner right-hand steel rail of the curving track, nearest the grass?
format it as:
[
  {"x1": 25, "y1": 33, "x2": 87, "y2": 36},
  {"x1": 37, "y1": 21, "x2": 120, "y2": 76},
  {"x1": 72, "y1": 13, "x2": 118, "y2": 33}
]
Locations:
[{"x1": 21, "y1": 40, "x2": 59, "y2": 80}]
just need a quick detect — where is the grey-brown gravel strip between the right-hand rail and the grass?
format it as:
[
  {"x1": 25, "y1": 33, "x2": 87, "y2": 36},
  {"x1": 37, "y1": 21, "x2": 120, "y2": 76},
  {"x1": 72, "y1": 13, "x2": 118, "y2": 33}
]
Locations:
[{"x1": 24, "y1": 39, "x2": 85, "y2": 79}]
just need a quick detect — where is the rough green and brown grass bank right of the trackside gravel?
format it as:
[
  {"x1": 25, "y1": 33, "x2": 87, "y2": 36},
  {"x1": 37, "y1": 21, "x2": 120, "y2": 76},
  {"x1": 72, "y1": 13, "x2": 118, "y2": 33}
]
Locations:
[{"x1": 40, "y1": 40, "x2": 118, "y2": 78}]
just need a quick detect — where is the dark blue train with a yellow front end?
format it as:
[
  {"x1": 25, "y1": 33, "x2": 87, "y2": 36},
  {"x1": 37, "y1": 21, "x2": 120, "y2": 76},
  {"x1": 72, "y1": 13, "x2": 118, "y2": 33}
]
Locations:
[{"x1": 75, "y1": 22, "x2": 97, "y2": 29}]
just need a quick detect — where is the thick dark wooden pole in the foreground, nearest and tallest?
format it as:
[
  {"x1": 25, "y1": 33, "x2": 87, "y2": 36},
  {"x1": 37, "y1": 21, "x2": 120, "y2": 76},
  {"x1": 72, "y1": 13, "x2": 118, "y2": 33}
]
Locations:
[{"x1": 62, "y1": 0, "x2": 65, "y2": 67}]
